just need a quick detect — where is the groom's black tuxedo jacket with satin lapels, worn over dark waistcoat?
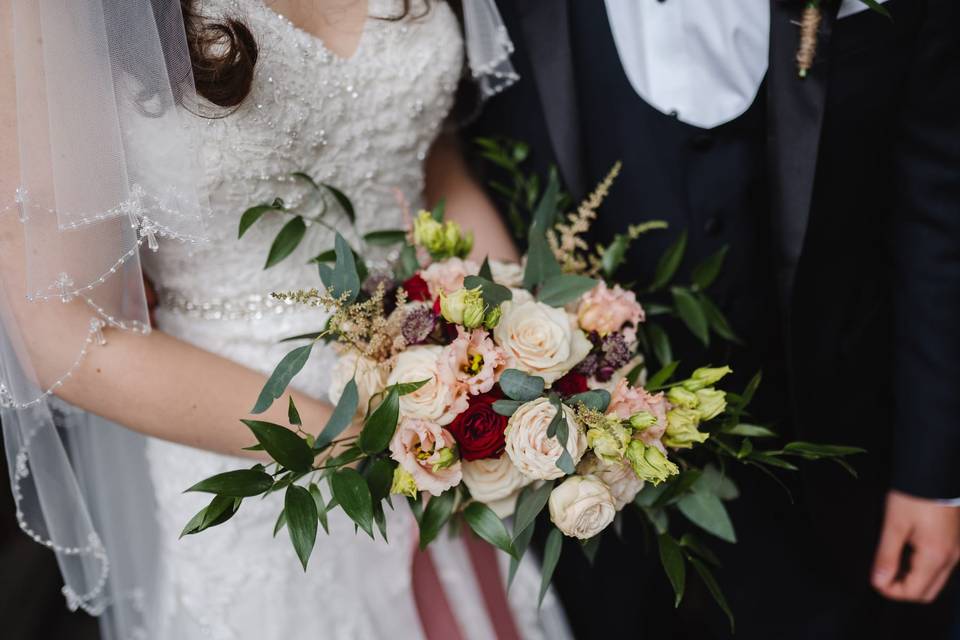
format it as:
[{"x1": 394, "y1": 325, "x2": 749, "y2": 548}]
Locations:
[{"x1": 468, "y1": 0, "x2": 960, "y2": 516}]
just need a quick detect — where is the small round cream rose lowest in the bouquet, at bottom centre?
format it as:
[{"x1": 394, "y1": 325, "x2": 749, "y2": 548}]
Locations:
[{"x1": 548, "y1": 476, "x2": 617, "y2": 540}]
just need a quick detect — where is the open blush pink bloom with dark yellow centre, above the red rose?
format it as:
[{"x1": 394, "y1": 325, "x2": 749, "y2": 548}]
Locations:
[{"x1": 440, "y1": 326, "x2": 507, "y2": 396}]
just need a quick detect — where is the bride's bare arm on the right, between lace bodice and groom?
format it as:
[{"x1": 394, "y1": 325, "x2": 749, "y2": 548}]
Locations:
[{"x1": 425, "y1": 134, "x2": 520, "y2": 262}]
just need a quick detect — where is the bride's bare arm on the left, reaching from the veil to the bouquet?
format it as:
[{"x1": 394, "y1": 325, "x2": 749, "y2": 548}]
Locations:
[{"x1": 0, "y1": 47, "x2": 330, "y2": 454}]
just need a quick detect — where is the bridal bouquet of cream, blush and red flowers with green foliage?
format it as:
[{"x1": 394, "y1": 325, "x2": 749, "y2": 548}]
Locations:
[{"x1": 184, "y1": 159, "x2": 855, "y2": 624}]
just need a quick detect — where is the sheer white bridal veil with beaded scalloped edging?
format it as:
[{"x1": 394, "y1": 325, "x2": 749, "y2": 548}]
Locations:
[{"x1": 0, "y1": 0, "x2": 516, "y2": 638}]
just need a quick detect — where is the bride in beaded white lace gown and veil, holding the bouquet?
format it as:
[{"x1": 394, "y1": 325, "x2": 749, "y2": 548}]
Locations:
[{"x1": 0, "y1": 0, "x2": 567, "y2": 640}]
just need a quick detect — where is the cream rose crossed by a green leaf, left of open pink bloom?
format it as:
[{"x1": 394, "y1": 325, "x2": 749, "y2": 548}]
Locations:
[{"x1": 387, "y1": 345, "x2": 467, "y2": 426}]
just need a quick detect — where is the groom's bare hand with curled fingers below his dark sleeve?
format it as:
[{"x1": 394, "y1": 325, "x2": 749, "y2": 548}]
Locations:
[{"x1": 873, "y1": 491, "x2": 960, "y2": 602}]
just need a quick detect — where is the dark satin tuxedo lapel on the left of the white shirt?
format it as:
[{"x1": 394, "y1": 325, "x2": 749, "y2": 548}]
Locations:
[{"x1": 516, "y1": 0, "x2": 584, "y2": 198}]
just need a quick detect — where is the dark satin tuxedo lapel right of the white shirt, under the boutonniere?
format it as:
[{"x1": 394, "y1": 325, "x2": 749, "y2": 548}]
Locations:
[{"x1": 767, "y1": 0, "x2": 839, "y2": 299}]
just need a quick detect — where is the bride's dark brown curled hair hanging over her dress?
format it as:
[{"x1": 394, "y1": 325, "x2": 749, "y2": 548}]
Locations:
[{"x1": 180, "y1": 0, "x2": 430, "y2": 107}]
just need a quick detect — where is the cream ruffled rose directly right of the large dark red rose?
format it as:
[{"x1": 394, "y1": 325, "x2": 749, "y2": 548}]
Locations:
[{"x1": 505, "y1": 398, "x2": 587, "y2": 480}]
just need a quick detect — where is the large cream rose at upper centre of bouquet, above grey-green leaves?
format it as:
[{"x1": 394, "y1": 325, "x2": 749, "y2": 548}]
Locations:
[{"x1": 493, "y1": 301, "x2": 593, "y2": 385}]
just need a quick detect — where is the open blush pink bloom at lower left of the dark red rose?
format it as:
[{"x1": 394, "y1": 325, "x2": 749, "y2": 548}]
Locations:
[{"x1": 390, "y1": 418, "x2": 463, "y2": 496}]
